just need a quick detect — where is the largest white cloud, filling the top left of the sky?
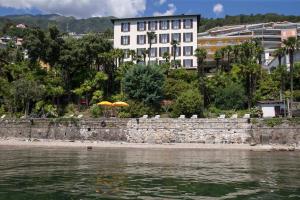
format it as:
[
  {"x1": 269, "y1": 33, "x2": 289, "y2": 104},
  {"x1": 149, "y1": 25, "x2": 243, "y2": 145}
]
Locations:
[{"x1": 0, "y1": 0, "x2": 146, "y2": 18}]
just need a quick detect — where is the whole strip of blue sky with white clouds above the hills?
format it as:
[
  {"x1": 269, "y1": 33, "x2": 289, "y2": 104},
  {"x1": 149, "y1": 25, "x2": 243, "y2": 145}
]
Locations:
[{"x1": 0, "y1": 0, "x2": 300, "y2": 18}]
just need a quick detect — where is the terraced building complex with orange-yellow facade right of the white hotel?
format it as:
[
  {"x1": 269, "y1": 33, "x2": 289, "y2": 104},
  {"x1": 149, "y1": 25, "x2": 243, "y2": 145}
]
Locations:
[{"x1": 198, "y1": 22, "x2": 300, "y2": 68}]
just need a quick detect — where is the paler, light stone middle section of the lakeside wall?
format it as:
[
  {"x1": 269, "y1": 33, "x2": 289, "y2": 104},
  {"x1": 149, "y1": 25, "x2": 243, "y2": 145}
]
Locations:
[{"x1": 127, "y1": 118, "x2": 251, "y2": 144}]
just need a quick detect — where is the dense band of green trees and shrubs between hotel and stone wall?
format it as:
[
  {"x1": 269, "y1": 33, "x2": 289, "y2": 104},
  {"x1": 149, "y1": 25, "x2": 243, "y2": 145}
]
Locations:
[{"x1": 0, "y1": 23, "x2": 300, "y2": 118}]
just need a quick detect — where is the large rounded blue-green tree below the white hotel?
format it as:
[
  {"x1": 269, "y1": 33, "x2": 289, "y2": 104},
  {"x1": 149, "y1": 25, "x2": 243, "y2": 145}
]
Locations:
[{"x1": 123, "y1": 65, "x2": 164, "y2": 105}]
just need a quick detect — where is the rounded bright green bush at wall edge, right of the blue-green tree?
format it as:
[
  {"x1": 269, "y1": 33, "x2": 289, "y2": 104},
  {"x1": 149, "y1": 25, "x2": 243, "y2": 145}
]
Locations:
[{"x1": 172, "y1": 89, "x2": 203, "y2": 117}]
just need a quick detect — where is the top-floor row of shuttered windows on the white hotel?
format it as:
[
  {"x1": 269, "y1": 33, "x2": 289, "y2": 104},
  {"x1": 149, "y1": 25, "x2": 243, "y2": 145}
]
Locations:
[{"x1": 121, "y1": 19, "x2": 193, "y2": 32}]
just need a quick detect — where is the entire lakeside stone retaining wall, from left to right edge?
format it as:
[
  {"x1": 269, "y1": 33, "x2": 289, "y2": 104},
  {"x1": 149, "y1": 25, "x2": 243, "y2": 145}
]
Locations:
[{"x1": 0, "y1": 118, "x2": 300, "y2": 145}]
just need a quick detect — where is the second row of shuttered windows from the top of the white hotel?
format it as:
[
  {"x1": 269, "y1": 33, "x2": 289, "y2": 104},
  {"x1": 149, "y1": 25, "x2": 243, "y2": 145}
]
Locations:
[{"x1": 121, "y1": 33, "x2": 193, "y2": 45}]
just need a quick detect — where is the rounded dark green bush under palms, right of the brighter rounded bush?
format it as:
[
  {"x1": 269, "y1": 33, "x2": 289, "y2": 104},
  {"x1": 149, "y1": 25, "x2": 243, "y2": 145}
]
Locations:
[{"x1": 214, "y1": 82, "x2": 247, "y2": 110}]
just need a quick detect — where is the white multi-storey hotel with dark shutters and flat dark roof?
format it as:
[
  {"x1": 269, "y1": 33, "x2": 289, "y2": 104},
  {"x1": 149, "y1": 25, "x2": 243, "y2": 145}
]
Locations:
[{"x1": 112, "y1": 15, "x2": 200, "y2": 68}]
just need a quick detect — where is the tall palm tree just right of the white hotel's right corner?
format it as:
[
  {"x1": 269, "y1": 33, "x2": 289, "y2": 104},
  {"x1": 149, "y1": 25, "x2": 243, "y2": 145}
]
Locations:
[{"x1": 194, "y1": 48, "x2": 207, "y2": 105}]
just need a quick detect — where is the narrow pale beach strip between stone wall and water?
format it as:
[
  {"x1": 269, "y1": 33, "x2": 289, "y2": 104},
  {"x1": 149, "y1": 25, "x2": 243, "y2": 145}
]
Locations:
[{"x1": 0, "y1": 138, "x2": 300, "y2": 151}]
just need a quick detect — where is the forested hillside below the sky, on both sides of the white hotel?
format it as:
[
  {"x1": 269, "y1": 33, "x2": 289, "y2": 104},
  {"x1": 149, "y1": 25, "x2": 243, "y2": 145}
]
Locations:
[{"x1": 0, "y1": 14, "x2": 300, "y2": 33}]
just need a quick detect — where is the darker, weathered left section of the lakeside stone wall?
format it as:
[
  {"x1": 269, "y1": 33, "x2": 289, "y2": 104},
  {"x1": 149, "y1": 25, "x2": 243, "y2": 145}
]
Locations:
[{"x1": 0, "y1": 119, "x2": 128, "y2": 141}]
